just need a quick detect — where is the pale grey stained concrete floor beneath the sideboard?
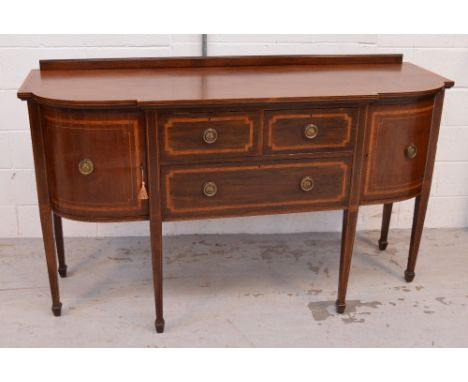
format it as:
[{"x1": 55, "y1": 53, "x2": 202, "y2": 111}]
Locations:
[{"x1": 0, "y1": 229, "x2": 468, "y2": 347}]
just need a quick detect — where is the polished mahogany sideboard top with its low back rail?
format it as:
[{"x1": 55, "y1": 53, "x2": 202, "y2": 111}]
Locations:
[{"x1": 18, "y1": 55, "x2": 453, "y2": 107}]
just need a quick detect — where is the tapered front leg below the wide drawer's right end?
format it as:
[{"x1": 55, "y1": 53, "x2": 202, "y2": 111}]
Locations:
[{"x1": 336, "y1": 208, "x2": 358, "y2": 313}]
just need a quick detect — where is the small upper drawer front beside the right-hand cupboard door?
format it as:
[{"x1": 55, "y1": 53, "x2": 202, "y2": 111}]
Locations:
[{"x1": 264, "y1": 108, "x2": 357, "y2": 154}]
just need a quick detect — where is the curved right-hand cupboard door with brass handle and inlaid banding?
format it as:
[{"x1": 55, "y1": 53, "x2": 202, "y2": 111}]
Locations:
[{"x1": 363, "y1": 98, "x2": 433, "y2": 200}]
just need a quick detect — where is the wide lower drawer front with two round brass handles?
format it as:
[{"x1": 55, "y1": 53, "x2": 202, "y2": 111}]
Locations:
[{"x1": 161, "y1": 160, "x2": 350, "y2": 220}]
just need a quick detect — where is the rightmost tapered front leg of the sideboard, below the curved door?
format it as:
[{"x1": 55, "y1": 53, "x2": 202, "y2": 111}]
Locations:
[{"x1": 405, "y1": 195, "x2": 429, "y2": 282}]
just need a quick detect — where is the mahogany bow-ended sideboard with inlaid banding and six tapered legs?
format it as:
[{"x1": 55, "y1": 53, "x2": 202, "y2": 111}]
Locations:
[{"x1": 18, "y1": 55, "x2": 454, "y2": 332}]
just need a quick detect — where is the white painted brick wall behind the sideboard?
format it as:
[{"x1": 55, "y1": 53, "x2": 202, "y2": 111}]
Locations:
[{"x1": 0, "y1": 35, "x2": 468, "y2": 237}]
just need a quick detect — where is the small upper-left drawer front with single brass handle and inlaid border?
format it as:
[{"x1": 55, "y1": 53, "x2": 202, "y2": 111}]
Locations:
[{"x1": 159, "y1": 112, "x2": 258, "y2": 161}]
